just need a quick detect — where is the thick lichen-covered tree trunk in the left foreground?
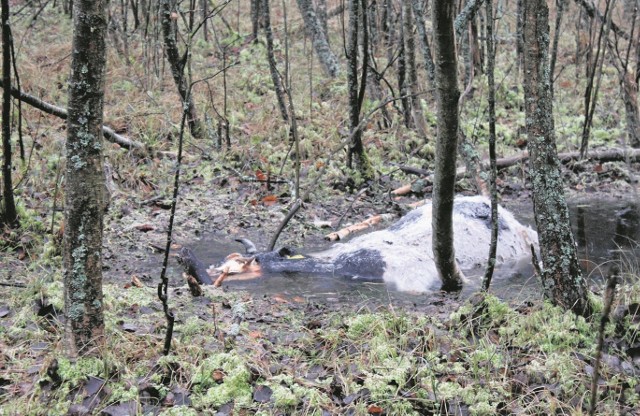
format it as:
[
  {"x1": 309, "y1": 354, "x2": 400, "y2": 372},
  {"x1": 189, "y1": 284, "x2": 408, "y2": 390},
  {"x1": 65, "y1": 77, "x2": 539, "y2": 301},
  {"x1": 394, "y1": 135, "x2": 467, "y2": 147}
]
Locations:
[{"x1": 64, "y1": 0, "x2": 108, "y2": 355}]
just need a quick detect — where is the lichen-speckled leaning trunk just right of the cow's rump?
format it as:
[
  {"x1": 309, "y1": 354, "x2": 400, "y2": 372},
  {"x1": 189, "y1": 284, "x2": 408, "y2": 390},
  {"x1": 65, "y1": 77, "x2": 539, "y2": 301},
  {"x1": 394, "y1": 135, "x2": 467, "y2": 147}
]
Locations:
[{"x1": 522, "y1": 0, "x2": 590, "y2": 315}]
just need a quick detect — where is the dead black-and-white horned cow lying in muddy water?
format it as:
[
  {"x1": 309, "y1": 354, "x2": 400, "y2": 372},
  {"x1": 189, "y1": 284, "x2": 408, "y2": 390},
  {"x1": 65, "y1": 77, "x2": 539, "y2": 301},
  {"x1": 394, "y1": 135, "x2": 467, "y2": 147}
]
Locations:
[{"x1": 181, "y1": 196, "x2": 538, "y2": 292}]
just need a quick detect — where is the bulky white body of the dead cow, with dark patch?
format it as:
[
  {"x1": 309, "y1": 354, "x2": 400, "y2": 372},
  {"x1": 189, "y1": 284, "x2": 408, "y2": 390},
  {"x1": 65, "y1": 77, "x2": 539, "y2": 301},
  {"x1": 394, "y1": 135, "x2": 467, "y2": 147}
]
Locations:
[{"x1": 312, "y1": 196, "x2": 538, "y2": 292}]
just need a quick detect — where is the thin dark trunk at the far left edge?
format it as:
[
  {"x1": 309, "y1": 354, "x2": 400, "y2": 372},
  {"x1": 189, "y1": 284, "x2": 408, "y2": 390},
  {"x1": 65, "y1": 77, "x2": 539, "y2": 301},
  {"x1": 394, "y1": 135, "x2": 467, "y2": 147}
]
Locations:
[{"x1": 0, "y1": 0, "x2": 18, "y2": 226}]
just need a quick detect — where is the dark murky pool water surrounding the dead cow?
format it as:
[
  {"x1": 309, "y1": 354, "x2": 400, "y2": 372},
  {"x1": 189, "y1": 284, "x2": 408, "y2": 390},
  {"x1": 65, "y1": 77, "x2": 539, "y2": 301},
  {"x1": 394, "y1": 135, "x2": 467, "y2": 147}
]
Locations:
[{"x1": 186, "y1": 198, "x2": 640, "y2": 306}]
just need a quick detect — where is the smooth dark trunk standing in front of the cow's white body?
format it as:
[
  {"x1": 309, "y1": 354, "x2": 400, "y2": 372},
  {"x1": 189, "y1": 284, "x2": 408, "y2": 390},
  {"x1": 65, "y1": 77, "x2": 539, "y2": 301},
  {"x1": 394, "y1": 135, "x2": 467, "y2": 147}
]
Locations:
[{"x1": 432, "y1": 0, "x2": 462, "y2": 290}]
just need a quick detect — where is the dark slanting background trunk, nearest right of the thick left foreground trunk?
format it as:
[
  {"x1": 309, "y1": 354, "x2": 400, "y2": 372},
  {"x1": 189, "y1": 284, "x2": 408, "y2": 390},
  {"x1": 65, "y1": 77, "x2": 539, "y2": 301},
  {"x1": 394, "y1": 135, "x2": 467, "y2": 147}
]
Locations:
[{"x1": 161, "y1": 0, "x2": 204, "y2": 139}]
